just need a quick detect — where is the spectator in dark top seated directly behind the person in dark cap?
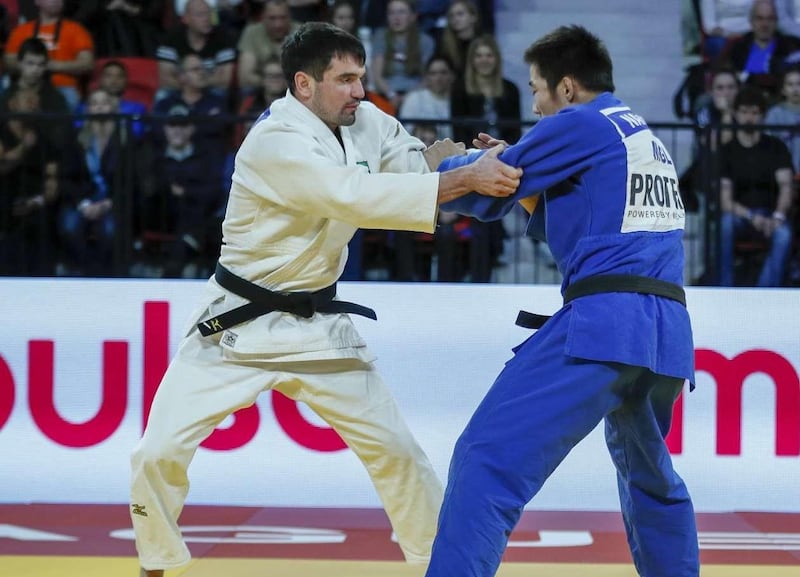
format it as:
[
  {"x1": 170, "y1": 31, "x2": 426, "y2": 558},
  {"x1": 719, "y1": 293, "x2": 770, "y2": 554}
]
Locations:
[{"x1": 153, "y1": 54, "x2": 229, "y2": 162}]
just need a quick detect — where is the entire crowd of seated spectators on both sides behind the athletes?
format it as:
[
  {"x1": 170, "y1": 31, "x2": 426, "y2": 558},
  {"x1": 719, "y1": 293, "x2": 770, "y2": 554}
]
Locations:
[{"x1": 0, "y1": 0, "x2": 800, "y2": 286}]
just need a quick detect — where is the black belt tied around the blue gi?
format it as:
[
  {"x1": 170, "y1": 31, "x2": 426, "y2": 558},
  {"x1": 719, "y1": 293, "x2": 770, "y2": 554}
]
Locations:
[{"x1": 516, "y1": 274, "x2": 686, "y2": 329}]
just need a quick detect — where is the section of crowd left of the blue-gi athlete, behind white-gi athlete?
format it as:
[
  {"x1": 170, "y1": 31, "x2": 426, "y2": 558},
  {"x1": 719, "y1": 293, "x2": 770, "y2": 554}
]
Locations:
[{"x1": 0, "y1": 0, "x2": 520, "y2": 282}]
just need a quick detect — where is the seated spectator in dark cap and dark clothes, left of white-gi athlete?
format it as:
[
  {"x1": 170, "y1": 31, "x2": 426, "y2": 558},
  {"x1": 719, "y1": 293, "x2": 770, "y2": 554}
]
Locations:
[{"x1": 142, "y1": 104, "x2": 225, "y2": 278}]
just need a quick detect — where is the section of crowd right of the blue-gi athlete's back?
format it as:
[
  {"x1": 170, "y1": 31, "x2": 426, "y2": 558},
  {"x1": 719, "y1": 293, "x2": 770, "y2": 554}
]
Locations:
[{"x1": 675, "y1": 0, "x2": 800, "y2": 287}]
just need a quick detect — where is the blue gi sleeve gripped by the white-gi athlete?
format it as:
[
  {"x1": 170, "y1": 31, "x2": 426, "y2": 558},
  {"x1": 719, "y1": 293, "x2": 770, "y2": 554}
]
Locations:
[{"x1": 439, "y1": 105, "x2": 618, "y2": 221}]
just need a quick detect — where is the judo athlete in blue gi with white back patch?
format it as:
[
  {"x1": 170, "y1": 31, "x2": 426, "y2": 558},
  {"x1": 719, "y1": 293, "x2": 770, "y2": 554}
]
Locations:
[{"x1": 426, "y1": 26, "x2": 699, "y2": 577}]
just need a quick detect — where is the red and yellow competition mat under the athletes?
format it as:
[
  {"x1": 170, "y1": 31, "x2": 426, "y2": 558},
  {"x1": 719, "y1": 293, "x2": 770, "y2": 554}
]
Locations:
[{"x1": 0, "y1": 504, "x2": 800, "y2": 577}]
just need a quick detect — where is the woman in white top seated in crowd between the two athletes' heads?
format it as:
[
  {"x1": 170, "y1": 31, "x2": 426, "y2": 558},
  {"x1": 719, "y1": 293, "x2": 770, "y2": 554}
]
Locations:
[{"x1": 399, "y1": 55, "x2": 455, "y2": 142}]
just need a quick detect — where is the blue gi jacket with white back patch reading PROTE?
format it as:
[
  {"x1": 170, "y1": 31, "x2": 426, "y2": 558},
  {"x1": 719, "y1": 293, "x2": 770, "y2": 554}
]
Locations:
[{"x1": 439, "y1": 93, "x2": 694, "y2": 383}]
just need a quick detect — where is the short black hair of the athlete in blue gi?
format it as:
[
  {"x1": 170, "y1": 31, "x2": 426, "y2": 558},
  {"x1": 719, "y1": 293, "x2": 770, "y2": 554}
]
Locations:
[{"x1": 525, "y1": 26, "x2": 614, "y2": 92}]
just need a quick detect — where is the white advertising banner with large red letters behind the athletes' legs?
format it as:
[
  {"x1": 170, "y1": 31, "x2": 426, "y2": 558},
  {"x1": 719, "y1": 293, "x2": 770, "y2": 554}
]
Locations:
[{"x1": 0, "y1": 279, "x2": 800, "y2": 512}]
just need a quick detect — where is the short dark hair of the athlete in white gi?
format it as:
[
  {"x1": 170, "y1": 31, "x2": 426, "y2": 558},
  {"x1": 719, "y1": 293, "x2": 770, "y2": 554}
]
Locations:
[{"x1": 281, "y1": 22, "x2": 367, "y2": 94}]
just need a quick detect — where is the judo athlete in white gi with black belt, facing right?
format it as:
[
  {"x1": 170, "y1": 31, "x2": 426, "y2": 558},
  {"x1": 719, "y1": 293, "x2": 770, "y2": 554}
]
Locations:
[{"x1": 131, "y1": 23, "x2": 522, "y2": 577}]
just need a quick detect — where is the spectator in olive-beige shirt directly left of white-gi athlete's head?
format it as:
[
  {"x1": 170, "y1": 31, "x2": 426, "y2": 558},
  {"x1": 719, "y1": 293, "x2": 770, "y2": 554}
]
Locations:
[{"x1": 237, "y1": 0, "x2": 298, "y2": 94}]
